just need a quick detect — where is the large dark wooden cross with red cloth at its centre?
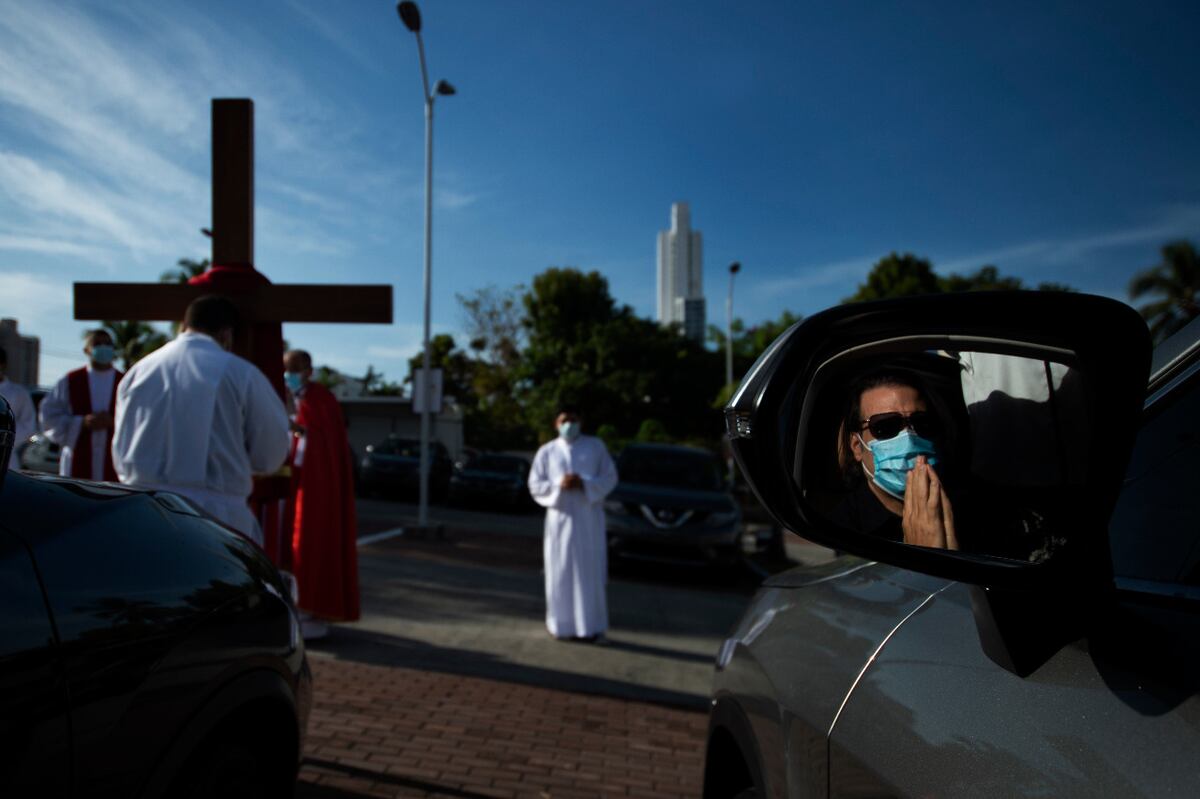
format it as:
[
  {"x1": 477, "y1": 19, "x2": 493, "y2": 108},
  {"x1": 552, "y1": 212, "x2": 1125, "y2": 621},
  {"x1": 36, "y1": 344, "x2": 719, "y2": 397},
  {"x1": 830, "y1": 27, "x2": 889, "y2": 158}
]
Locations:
[{"x1": 74, "y1": 98, "x2": 391, "y2": 396}]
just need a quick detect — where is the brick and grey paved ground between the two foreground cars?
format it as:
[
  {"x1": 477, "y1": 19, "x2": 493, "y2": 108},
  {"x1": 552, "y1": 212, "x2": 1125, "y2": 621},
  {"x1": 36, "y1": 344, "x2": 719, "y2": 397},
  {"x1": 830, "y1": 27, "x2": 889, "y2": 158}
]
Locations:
[{"x1": 296, "y1": 500, "x2": 820, "y2": 798}]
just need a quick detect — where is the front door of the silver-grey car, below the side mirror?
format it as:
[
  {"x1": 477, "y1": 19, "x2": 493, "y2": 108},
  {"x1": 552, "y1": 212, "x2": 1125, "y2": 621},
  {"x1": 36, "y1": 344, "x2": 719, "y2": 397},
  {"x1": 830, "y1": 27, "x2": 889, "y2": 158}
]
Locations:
[{"x1": 829, "y1": 352, "x2": 1200, "y2": 797}]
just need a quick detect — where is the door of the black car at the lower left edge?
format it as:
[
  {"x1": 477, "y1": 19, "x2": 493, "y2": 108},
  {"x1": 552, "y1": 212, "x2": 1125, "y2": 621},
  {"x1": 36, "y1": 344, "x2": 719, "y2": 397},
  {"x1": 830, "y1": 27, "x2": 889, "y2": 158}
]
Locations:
[{"x1": 0, "y1": 529, "x2": 71, "y2": 797}]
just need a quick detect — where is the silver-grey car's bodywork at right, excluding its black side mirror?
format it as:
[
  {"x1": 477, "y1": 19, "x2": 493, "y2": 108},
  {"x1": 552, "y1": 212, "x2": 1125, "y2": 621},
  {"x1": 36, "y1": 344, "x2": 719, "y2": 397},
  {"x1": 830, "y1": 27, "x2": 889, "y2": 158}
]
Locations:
[{"x1": 706, "y1": 311, "x2": 1200, "y2": 799}]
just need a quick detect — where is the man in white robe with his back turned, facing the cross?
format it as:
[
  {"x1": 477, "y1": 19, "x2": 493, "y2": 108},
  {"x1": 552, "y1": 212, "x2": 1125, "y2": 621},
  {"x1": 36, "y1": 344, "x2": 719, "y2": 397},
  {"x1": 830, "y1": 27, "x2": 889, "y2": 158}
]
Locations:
[{"x1": 113, "y1": 295, "x2": 290, "y2": 546}]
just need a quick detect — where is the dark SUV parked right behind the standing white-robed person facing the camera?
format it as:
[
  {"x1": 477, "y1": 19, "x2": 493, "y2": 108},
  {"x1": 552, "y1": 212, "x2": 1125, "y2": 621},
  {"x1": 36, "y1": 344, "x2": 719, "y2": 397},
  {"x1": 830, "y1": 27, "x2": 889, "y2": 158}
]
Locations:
[{"x1": 605, "y1": 444, "x2": 742, "y2": 564}]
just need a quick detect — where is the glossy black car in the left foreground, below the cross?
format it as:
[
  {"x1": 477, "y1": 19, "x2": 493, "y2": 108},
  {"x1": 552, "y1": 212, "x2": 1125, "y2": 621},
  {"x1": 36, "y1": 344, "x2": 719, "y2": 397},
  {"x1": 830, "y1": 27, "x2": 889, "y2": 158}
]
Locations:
[{"x1": 0, "y1": 393, "x2": 312, "y2": 798}]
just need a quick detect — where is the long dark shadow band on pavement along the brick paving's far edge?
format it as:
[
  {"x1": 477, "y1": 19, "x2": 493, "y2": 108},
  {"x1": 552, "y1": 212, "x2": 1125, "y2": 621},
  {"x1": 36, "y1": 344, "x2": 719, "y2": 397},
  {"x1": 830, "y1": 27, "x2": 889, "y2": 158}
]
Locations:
[{"x1": 306, "y1": 627, "x2": 712, "y2": 710}]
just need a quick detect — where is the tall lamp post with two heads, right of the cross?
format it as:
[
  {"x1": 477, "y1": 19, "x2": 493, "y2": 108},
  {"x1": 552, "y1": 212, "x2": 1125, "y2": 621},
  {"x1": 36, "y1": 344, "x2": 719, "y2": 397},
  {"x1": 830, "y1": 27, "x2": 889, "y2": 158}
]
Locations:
[{"x1": 396, "y1": 0, "x2": 455, "y2": 528}]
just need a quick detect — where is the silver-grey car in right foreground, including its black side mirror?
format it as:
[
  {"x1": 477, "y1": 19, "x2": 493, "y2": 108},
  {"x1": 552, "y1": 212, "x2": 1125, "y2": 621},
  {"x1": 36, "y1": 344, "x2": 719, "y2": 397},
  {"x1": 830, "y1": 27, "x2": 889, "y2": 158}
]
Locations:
[{"x1": 704, "y1": 292, "x2": 1200, "y2": 799}]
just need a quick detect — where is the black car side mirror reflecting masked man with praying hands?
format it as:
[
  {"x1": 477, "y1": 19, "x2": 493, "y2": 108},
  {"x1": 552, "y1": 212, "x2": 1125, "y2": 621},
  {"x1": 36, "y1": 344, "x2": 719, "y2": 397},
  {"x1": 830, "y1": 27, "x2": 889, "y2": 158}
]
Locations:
[{"x1": 725, "y1": 292, "x2": 1151, "y2": 588}]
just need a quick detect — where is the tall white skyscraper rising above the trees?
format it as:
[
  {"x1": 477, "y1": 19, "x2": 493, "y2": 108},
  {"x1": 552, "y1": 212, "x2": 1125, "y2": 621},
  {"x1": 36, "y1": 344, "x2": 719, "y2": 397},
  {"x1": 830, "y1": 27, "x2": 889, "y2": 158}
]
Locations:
[{"x1": 659, "y1": 203, "x2": 704, "y2": 341}]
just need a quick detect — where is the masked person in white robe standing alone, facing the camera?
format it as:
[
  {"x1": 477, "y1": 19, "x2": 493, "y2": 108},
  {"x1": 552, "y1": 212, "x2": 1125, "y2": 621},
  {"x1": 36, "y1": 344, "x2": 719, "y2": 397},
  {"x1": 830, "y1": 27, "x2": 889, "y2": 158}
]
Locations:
[{"x1": 529, "y1": 410, "x2": 617, "y2": 641}]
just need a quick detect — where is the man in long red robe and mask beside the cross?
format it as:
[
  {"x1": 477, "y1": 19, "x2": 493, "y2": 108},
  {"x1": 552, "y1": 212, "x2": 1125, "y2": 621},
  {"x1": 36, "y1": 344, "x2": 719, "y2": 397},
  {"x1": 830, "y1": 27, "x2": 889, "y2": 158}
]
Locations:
[{"x1": 283, "y1": 349, "x2": 359, "y2": 638}]
